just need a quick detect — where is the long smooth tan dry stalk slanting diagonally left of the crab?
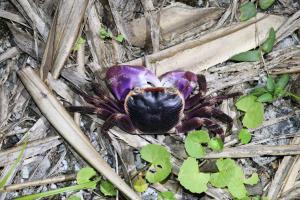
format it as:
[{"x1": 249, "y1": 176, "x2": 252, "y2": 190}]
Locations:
[{"x1": 18, "y1": 67, "x2": 140, "y2": 200}]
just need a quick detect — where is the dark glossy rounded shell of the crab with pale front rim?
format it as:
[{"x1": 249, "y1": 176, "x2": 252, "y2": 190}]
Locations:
[{"x1": 124, "y1": 87, "x2": 184, "y2": 133}]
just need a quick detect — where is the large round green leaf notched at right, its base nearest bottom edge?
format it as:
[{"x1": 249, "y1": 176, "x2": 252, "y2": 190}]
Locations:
[{"x1": 178, "y1": 157, "x2": 210, "y2": 194}]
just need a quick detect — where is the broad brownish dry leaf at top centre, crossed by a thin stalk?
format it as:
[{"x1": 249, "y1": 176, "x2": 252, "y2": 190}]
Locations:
[{"x1": 124, "y1": 0, "x2": 224, "y2": 47}]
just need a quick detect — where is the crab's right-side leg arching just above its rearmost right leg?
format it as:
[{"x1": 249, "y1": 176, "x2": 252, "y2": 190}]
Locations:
[{"x1": 185, "y1": 106, "x2": 233, "y2": 130}]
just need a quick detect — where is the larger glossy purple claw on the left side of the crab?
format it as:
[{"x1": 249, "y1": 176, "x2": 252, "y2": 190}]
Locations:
[{"x1": 105, "y1": 65, "x2": 161, "y2": 101}]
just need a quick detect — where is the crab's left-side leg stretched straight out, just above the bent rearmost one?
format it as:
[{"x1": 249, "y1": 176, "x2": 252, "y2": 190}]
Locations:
[{"x1": 66, "y1": 106, "x2": 113, "y2": 120}]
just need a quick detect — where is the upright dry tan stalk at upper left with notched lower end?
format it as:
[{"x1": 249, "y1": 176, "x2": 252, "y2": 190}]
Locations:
[{"x1": 40, "y1": 0, "x2": 89, "y2": 79}]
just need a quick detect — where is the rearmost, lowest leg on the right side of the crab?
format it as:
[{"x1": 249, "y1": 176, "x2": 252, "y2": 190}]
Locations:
[{"x1": 176, "y1": 117, "x2": 224, "y2": 140}]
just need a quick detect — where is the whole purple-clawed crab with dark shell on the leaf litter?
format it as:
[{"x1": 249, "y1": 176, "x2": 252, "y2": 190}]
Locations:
[{"x1": 69, "y1": 65, "x2": 240, "y2": 139}]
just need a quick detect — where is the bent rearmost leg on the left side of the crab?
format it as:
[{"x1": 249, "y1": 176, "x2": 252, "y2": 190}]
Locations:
[{"x1": 101, "y1": 113, "x2": 136, "y2": 134}]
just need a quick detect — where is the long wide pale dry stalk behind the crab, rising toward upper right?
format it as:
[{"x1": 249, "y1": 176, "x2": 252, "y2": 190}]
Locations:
[{"x1": 124, "y1": 14, "x2": 285, "y2": 75}]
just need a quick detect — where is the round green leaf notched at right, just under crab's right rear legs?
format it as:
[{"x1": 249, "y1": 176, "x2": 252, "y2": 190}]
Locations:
[{"x1": 184, "y1": 130, "x2": 210, "y2": 158}]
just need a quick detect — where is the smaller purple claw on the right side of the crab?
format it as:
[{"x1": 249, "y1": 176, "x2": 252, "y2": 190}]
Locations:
[{"x1": 160, "y1": 70, "x2": 197, "y2": 99}]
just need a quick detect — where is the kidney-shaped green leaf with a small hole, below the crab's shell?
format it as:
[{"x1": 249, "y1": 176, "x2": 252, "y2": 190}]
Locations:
[{"x1": 141, "y1": 144, "x2": 172, "y2": 183}]
